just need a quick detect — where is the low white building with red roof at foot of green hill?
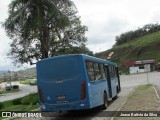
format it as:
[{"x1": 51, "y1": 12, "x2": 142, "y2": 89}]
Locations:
[{"x1": 122, "y1": 60, "x2": 155, "y2": 73}]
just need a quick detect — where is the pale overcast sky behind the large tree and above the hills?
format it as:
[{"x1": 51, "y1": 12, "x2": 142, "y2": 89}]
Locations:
[{"x1": 0, "y1": 0, "x2": 160, "y2": 71}]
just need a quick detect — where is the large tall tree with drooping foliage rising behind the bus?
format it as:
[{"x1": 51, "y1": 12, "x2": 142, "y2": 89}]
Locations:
[{"x1": 3, "y1": 0, "x2": 87, "y2": 64}]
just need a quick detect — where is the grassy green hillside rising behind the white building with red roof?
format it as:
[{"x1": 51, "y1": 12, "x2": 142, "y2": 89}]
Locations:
[{"x1": 95, "y1": 31, "x2": 160, "y2": 70}]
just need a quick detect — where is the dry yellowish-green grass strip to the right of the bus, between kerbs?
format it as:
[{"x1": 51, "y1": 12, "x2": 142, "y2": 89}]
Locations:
[{"x1": 114, "y1": 84, "x2": 160, "y2": 120}]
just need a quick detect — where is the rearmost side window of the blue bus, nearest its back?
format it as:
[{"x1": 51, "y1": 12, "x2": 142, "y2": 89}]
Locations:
[{"x1": 86, "y1": 61, "x2": 94, "y2": 81}]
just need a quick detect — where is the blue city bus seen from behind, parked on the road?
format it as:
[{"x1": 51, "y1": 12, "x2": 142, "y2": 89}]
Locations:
[{"x1": 36, "y1": 54, "x2": 121, "y2": 111}]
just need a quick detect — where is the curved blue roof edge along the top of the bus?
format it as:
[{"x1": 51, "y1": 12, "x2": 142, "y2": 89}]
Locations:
[{"x1": 37, "y1": 54, "x2": 117, "y2": 66}]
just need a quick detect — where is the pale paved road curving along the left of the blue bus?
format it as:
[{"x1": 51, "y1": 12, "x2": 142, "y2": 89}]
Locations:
[{"x1": 0, "y1": 83, "x2": 37, "y2": 102}]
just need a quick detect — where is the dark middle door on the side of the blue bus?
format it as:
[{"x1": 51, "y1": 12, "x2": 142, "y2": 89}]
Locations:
[{"x1": 105, "y1": 65, "x2": 112, "y2": 98}]
